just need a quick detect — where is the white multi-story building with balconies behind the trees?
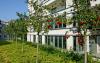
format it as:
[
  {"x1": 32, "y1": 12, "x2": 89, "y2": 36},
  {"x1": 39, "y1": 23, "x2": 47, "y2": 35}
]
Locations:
[{"x1": 27, "y1": 0, "x2": 100, "y2": 53}]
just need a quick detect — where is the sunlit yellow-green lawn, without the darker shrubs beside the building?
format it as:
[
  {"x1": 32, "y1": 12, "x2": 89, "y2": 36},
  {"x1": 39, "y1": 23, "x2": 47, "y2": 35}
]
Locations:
[{"x1": 0, "y1": 41, "x2": 63, "y2": 63}]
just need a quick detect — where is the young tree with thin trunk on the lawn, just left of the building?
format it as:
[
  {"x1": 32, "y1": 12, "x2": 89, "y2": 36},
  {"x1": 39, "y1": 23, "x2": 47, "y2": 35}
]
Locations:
[{"x1": 15, "y1": 12, "x2": 28, "y2": 52}]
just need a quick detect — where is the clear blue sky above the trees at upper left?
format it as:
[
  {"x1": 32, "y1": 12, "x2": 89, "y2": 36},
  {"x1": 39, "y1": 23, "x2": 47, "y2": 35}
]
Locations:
[{"x1": 0, "y1": 0, "x2": 27, "y2": 21}]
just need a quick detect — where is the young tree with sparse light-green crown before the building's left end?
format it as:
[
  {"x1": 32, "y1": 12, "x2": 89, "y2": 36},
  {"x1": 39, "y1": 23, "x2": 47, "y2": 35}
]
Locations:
[{"x1": 28, "y1": 1, "x2": 48, "y2": 63}]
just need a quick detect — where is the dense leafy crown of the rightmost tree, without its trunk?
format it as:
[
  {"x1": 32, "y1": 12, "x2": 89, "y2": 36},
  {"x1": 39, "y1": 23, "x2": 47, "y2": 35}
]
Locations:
[{"x1": 73, "y1": 0, "x2": 100, "y2": 31}]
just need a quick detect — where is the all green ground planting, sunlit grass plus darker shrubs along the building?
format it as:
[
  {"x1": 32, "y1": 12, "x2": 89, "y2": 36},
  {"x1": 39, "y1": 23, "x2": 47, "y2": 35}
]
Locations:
[{"x1": 0, "y1": 41, "x2": 100, "y2": 63}]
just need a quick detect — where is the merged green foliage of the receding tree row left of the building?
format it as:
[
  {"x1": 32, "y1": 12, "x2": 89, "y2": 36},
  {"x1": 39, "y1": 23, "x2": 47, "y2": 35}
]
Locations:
[{"x1": 3, "y1": 13, "x2": 28, "y2": 40}]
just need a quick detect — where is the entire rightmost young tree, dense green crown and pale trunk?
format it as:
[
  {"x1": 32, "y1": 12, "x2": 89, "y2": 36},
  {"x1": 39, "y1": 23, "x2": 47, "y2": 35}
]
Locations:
[{"x1": 73, "y1": 0, "x2": 100, "y2": 63}]
